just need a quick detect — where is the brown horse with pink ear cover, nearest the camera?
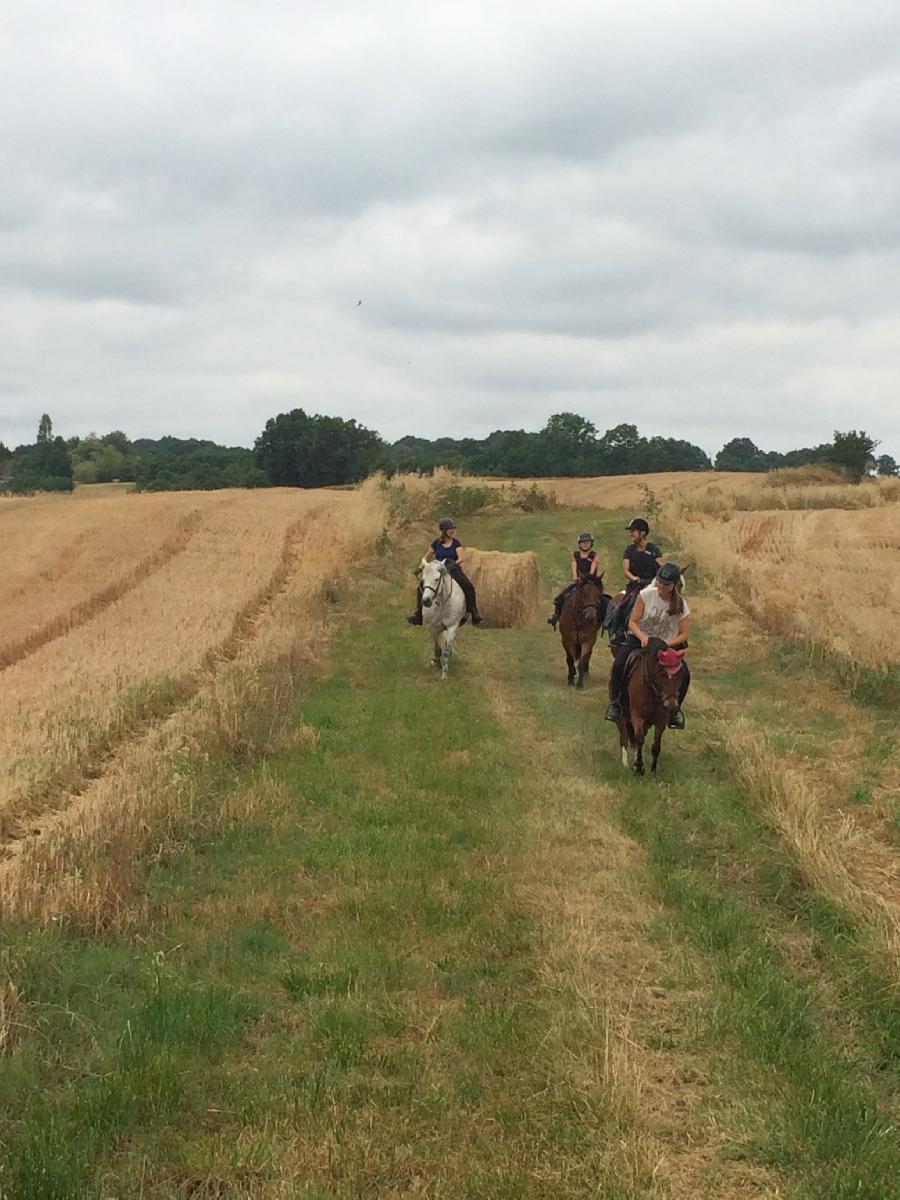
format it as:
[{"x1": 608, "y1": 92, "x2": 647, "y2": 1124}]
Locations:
[{"x1": 618, "y1": 637, "x2": 684, "y2": 775}]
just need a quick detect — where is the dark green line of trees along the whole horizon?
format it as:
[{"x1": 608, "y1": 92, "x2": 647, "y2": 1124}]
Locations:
[{"x1": 0, "y1": 408, "x2": 898, "y2": 493}]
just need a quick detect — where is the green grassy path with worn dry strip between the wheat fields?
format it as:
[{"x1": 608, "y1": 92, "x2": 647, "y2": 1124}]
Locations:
[{"x1": 0, "y1": 512, "x2": 900, "y2": 1200}]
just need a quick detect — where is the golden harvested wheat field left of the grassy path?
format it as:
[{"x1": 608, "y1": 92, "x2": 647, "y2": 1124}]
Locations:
[{"x1": 0, "y1": 490, "x2": 380, "y2": 912}]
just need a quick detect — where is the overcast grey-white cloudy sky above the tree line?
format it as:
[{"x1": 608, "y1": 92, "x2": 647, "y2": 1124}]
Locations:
[{"x1": 0, "y1": 0, "x2": 900, "y2": 457}]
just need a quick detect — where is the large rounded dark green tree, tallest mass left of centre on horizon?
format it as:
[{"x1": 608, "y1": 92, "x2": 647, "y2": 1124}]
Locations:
[{"x1": 254, "y1": 408, "x2": 384, "y2": 487}]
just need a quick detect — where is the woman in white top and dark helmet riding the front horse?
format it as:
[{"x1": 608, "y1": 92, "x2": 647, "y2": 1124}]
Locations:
[{"x1": 606, "y1": 563, "x2": 691, "y2": 730}]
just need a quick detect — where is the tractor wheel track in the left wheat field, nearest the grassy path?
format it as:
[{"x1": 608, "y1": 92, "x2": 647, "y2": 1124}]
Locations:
[{"x1": 0, "y1": 512, "x2": 309, "y2": 860}]
